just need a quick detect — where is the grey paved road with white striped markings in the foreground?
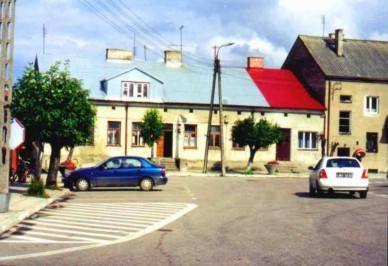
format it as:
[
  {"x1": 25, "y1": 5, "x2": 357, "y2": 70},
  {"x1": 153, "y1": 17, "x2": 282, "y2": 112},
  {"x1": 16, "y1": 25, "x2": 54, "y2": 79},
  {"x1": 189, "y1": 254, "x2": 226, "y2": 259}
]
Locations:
[{"x1": 0, "y1": 177, "x2": 388, "y2": 265}]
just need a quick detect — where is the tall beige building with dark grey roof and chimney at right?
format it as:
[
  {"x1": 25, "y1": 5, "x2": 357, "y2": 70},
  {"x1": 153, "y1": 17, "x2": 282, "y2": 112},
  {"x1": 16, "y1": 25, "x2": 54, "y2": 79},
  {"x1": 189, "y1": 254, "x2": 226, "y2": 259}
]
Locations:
[{"x1": 283, "y1": 29, "x2": 388, "y2": 177}]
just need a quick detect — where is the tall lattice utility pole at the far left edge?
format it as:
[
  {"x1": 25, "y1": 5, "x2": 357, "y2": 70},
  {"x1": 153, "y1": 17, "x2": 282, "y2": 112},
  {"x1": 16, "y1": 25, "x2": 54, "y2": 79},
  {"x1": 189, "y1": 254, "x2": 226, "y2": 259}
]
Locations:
[{"x1": 0, "y1": 0, "x2": 16, "y2": 213}]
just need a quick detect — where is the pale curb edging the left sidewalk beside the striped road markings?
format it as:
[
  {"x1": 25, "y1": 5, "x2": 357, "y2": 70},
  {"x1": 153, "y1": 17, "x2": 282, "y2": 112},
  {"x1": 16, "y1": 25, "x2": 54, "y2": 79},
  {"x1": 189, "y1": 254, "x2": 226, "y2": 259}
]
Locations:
[{"x1": 0, "y1": 189, "x2": 70, "y2": 236}]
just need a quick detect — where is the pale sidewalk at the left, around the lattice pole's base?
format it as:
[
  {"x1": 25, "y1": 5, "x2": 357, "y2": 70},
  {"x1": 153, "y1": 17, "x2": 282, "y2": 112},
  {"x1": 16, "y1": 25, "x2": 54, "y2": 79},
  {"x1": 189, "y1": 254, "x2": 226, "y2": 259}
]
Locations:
[{"x1": 0, "y1": 187, "x2": 69, "y2": 235}]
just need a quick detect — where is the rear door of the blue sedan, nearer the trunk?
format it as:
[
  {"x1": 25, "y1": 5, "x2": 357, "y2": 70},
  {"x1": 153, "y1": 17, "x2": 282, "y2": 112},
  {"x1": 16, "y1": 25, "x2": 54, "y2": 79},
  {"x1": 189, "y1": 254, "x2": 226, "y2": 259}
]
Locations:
[{"x1": 119, "y1": 157, "x2": 143, "y2": 186}]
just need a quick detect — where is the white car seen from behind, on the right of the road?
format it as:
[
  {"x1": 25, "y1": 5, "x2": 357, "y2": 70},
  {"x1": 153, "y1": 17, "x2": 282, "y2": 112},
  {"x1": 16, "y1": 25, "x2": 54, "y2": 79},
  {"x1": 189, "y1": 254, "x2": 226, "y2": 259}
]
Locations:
[{"x1": 309, "y1": 157, "x2": 369, "y2": 199}]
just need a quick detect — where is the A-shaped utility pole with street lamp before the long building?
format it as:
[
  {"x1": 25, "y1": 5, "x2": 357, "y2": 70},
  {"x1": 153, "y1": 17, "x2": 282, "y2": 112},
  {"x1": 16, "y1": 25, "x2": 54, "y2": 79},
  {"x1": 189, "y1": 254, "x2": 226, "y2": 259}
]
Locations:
[{"x1": 203, "y1": 43, "x2": 234, "y2": 176}]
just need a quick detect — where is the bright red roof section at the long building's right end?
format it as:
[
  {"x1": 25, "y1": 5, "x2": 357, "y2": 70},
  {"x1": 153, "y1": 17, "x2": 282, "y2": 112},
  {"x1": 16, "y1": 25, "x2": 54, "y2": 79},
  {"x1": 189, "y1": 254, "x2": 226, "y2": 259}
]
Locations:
[{"x1": 247, "y1": 68, "x2": 325, "y2": 111}]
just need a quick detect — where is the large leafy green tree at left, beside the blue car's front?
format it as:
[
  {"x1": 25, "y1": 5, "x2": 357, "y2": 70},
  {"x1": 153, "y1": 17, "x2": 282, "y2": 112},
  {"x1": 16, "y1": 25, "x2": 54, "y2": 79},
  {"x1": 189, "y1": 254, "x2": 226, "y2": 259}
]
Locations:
[{"x1": 11, "y1": 62, "x2": 95, "y2": 187}]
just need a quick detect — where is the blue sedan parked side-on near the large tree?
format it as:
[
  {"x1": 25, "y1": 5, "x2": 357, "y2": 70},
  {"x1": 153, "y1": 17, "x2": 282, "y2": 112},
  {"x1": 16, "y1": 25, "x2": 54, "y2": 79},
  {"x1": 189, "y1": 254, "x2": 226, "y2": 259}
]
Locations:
[{"x1": 63, "y1": 156, "x2": 168, "y2": 191}]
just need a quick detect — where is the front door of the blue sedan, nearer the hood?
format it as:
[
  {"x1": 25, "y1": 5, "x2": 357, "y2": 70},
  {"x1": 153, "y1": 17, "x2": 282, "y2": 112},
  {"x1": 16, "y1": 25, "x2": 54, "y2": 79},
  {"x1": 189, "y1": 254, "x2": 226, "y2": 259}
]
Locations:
[{"x1": 95, "y1": 158, "x2": 122, "y2": 187}]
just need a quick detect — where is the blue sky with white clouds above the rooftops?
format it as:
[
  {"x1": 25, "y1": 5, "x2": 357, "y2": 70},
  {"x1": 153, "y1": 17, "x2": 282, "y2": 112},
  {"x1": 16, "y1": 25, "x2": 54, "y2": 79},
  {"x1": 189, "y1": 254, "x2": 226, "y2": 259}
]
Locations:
[{"x1": 14, "y1": 0, "x2": 388, "y2": 78}]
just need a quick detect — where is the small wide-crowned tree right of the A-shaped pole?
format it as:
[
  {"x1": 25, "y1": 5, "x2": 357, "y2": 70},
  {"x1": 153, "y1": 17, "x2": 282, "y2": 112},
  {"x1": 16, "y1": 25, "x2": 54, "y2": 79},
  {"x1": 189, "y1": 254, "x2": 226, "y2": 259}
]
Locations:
[{"x1": 232, "y1": 117, "x2": 282, "y2": 170}]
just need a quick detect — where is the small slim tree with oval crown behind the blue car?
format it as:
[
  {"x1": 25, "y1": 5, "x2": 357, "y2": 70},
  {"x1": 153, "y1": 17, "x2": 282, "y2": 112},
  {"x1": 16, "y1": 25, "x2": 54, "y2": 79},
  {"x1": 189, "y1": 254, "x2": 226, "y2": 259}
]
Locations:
[{"x1": 140, "y1": 109, "x2": 163, "y2": 158}]
